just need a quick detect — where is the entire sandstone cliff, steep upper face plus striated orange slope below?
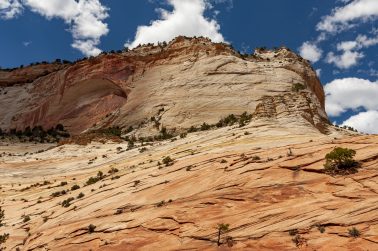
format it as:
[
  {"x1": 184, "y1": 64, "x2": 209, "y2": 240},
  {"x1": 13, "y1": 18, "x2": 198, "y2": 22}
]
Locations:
[{"x1": 0, "y1": 37, "x2": 378, "y2": 251}]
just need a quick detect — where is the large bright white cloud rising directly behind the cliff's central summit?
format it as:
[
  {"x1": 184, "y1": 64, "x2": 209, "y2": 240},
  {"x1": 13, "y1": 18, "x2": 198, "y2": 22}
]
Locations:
[{"x1": 125, "y1": 0, "x2": 224, "y2": 48}]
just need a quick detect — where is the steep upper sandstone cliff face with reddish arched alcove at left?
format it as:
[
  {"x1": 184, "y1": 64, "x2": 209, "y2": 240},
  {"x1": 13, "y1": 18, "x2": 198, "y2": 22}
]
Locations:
[{"x1": 0, "y1": 37, "x2": 328, "y2": 135}]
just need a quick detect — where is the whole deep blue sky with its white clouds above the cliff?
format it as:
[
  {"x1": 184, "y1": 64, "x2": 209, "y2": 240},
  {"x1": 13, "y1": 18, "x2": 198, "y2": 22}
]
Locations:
[{"x1": 0, "y1": 0, "x2": 378, "y2": 133}]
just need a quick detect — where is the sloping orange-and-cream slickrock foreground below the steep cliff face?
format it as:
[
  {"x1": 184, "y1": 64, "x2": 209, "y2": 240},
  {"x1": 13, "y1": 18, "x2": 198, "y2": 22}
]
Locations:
[{"x1": 0, "y1": 121, "x2": 378, "y2": 251}]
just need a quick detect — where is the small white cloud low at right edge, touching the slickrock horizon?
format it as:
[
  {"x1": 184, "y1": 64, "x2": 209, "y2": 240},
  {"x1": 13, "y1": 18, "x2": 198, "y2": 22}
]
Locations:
[{"x1": 342, "y1": 110, "x2": 378, "y2": 134}]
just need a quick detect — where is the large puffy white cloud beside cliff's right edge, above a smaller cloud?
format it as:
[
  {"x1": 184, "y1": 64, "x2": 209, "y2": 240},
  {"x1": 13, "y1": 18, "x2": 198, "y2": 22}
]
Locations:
[{"x1": 324, "y1": 78, "x2": 378, "y2": 116}]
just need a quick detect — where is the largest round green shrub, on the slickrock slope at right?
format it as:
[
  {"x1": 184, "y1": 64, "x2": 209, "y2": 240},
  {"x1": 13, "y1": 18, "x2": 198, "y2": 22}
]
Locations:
[{"x1": 324, "y1": 147, "x2": 358, "y2": 174}]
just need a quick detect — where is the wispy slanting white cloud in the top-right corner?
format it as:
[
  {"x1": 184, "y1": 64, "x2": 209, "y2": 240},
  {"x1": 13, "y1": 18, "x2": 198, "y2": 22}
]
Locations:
[{"x1": 316, "y1": 0, "x2": 378, "y2": 33}]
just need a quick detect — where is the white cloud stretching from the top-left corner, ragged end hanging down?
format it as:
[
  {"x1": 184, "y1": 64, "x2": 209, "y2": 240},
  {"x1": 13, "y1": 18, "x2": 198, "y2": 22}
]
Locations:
[{"x1": 0, "y1": 0, "x2": 109, "y2": 56}]
